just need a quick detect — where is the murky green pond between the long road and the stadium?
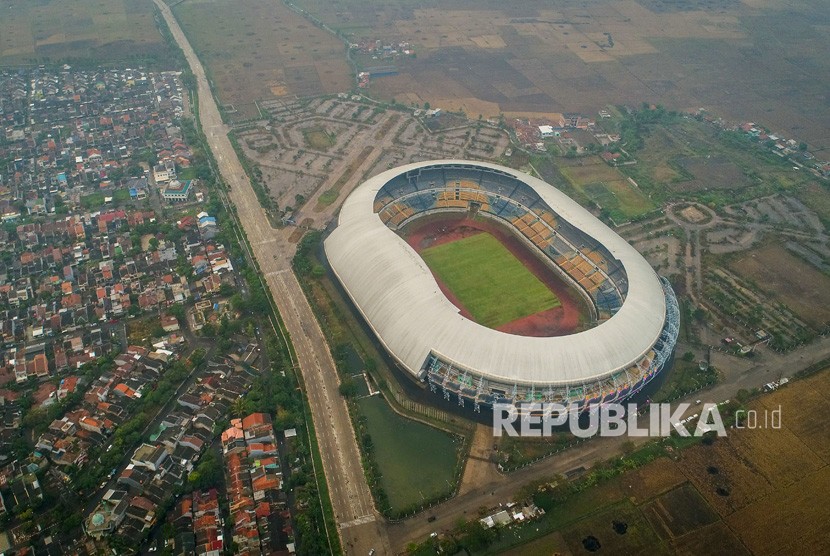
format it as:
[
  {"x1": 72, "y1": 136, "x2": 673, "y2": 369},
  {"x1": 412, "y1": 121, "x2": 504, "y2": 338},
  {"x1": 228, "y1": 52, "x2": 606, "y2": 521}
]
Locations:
[{"x1": 358, "y1": 396, "x2": 459, "y2": 512}]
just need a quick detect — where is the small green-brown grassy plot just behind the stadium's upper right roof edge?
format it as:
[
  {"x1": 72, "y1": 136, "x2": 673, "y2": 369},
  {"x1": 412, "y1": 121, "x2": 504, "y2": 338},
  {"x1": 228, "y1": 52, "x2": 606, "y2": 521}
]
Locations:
[{"x1": 559, "y1": 157, "x2": 656, "y2": 223}]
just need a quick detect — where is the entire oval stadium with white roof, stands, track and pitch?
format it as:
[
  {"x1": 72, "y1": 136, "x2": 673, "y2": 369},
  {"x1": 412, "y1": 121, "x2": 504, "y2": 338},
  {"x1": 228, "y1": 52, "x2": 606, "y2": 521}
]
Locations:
[{"x1": 324, "y1": 160, "x2": 679, "y2": 411}]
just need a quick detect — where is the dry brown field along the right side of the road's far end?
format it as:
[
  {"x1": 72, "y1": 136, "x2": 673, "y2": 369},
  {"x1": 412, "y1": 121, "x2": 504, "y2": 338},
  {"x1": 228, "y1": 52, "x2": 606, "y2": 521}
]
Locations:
[{"x1": 173, "y1": 0, "x2": 354, "y2": 120}]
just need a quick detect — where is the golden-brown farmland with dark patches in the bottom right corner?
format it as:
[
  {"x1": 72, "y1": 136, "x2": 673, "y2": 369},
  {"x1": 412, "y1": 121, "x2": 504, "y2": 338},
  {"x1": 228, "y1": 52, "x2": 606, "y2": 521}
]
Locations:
[{"x1": 488, "y1": 369, "x2": 830, "y2": 555}]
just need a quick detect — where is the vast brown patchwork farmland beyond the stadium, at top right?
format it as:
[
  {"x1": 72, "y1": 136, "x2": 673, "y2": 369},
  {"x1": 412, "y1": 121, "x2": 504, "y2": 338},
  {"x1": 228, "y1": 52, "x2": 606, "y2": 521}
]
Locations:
[{"x1": 296, "y1": 0, "x2": 830, "y2": 148}]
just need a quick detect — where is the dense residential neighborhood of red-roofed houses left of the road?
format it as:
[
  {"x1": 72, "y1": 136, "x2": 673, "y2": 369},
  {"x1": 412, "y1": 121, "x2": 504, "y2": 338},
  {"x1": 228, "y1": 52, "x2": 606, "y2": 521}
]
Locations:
[{"x1": 0, "y1": 65, "x2": 304, "y2": 554}]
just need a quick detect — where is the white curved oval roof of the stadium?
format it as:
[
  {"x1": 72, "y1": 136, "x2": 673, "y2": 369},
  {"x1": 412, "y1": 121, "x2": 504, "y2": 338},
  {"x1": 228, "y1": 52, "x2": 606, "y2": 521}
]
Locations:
[{"x1": 325, "y1": 160, "x2": 666, "y2": 385}]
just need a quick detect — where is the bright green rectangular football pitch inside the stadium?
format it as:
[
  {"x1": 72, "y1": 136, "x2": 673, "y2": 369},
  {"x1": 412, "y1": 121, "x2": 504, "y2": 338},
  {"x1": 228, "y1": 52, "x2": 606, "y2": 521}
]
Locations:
[{"x1": 421, "y1": 233, "x2": 560, "y2": 328}]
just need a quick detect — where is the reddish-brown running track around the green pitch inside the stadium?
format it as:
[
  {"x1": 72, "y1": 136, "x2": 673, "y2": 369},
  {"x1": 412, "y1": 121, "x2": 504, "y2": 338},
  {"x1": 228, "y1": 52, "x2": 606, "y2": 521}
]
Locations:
[{"x1": 402, "y1": 215, "x2": 587, "y2": 337}]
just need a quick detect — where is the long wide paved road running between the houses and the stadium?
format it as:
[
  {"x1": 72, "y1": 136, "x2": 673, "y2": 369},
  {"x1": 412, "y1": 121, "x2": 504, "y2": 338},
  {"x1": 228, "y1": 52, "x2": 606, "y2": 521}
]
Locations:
[{"x1": 154, "y1": 0, "x2": 390, "y2": 554}]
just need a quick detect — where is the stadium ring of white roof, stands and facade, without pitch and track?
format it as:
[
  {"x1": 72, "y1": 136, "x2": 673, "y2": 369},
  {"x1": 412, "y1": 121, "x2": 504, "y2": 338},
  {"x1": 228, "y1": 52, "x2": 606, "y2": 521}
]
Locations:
[{"x1": 324, "y1": 160, "x2": 679, "y2": 411}]
